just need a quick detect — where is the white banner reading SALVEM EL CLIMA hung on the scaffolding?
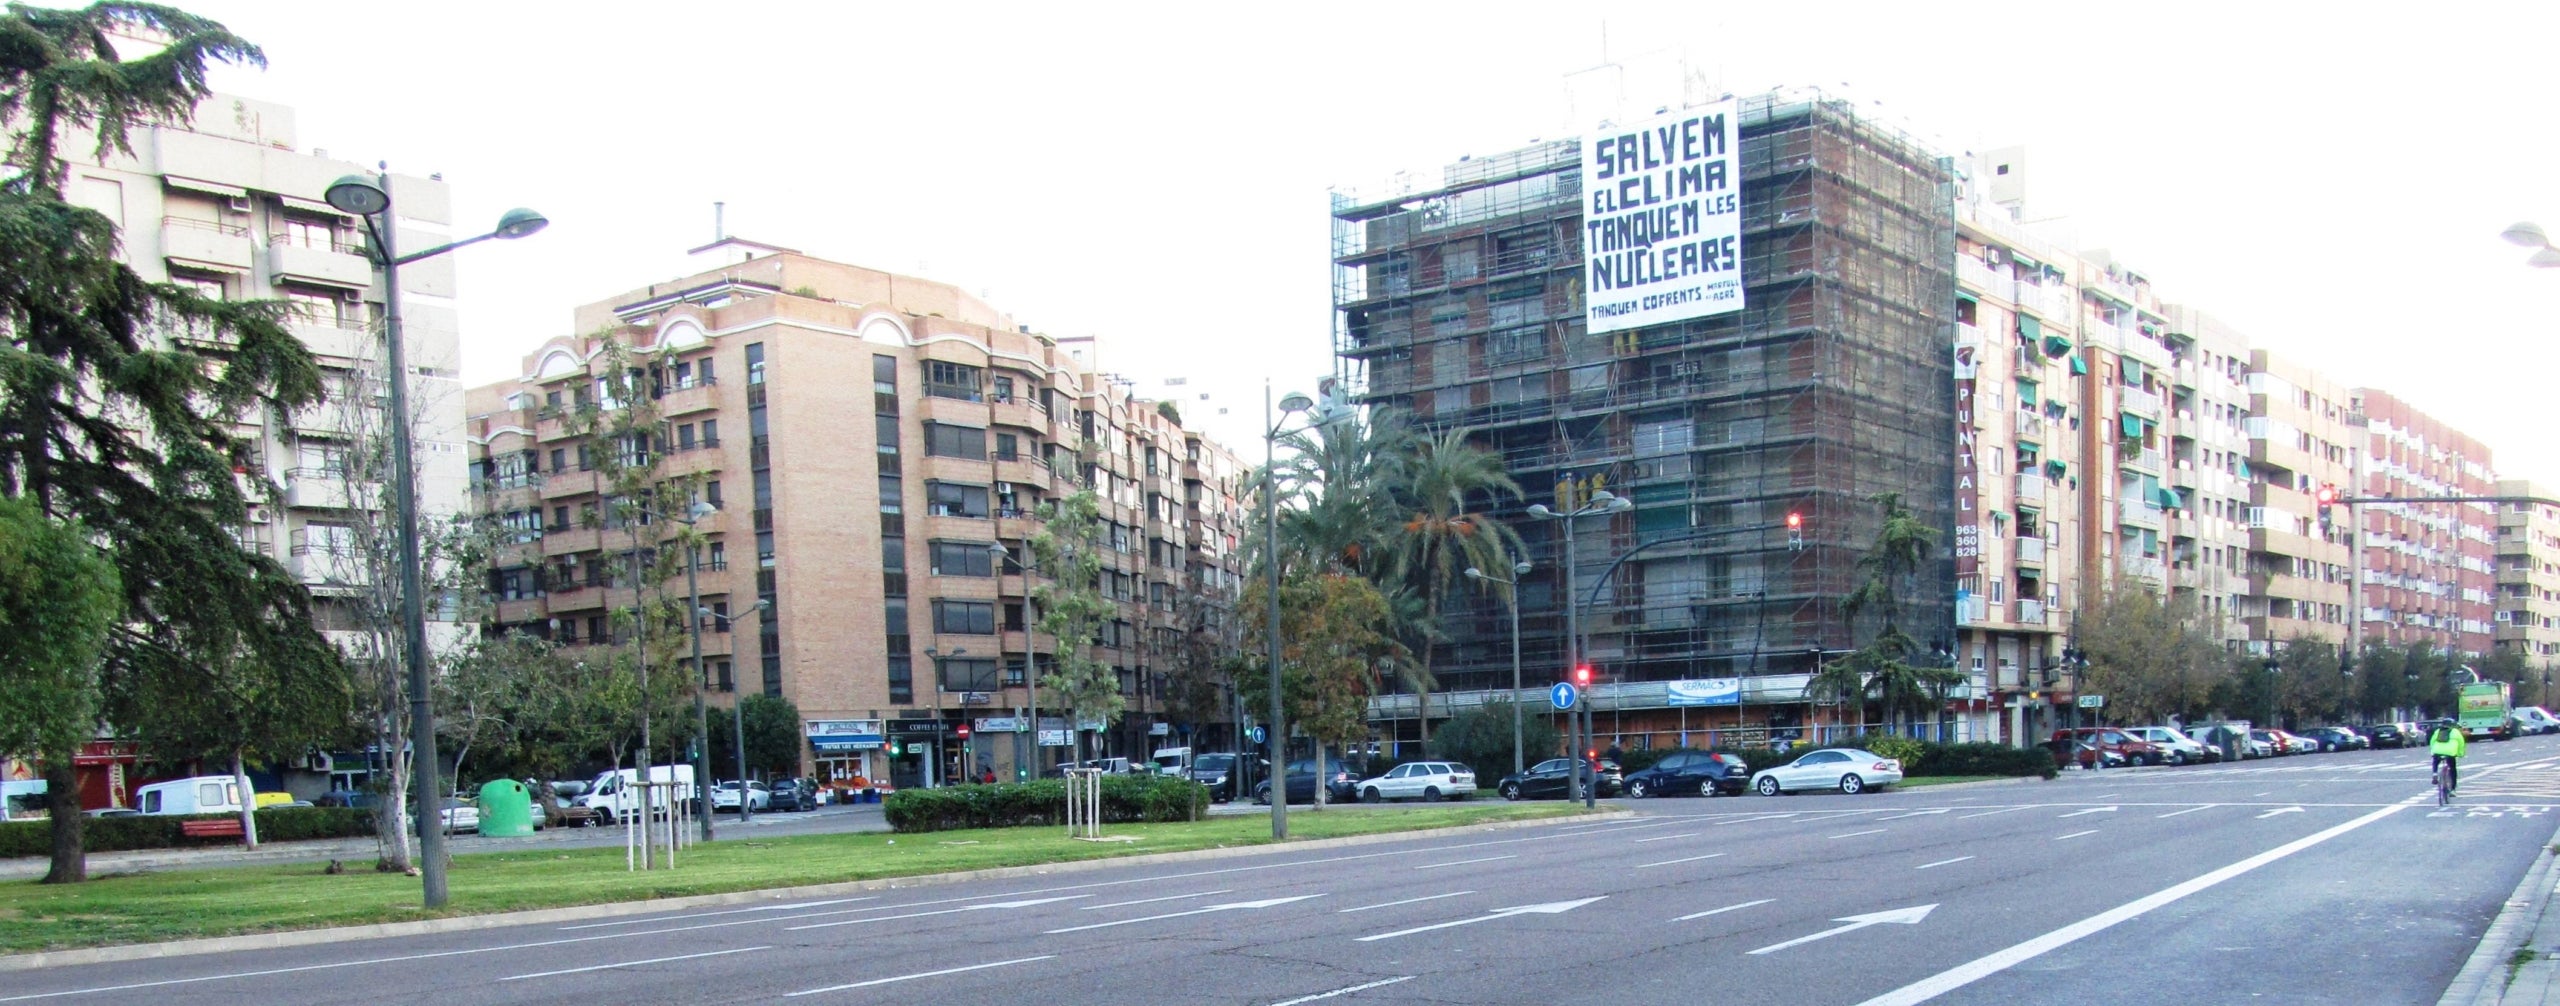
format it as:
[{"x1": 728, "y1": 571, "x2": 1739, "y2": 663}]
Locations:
[{"x1": 1582, "y1": 100, "x2": 1743, "y2": 335}]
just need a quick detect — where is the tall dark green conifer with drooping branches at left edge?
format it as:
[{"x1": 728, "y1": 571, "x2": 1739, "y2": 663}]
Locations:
[{"x1": 0, "y1": 3, "x2": 348, "y2": 883}]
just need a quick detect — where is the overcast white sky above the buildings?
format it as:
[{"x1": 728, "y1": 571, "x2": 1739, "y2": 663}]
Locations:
[{"x1": 177, "y1": 0, "x2": 2560, "y2": 476}]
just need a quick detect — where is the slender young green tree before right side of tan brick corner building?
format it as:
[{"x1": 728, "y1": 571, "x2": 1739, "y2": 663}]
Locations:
[{"x1": 1032, "y1": 489, "x2": 1126, "y2": 760}]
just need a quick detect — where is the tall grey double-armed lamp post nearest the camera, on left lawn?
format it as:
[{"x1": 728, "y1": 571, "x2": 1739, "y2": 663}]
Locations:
[{"x1": 325, "y1": 166, "x2": 550, "y2": 909}]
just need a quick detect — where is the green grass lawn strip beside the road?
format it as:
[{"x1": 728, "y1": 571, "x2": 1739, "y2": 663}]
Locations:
[{"x1": 0, "y1": 804, "x2": 1580, "y2": 952}]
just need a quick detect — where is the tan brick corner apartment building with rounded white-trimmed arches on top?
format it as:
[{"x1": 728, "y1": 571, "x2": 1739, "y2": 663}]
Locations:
[{"x1": 471, "y1": 238, "x2": 1247, "y2": 786}]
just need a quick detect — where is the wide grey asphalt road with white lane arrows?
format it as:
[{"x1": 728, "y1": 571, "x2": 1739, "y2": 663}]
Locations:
[{"x1": 20, "y1": 737, "x2": 2560, "y2": 1006}]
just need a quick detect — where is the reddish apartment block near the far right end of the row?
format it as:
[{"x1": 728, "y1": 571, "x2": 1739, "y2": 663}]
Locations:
[{"x1": 2340, "y1": 389, "x2": 2499, "y2": 653}]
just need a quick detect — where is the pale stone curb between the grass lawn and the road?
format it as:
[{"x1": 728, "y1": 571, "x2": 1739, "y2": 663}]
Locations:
[{"x1": 0, "y1": 809, "x2": 1636, "y2": 973}]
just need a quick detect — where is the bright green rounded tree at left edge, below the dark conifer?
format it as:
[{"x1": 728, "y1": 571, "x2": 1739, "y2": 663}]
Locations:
[{"x1": 0, "y1": 497, "x2": 125, "y2": 873}]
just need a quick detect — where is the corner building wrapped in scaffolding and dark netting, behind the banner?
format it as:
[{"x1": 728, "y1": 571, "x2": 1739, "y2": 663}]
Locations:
[{"x1": 1334, "y1": 90, "x2": 1971, "y2": 747}]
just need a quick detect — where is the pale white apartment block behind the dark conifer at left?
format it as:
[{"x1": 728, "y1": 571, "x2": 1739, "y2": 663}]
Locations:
[{"x1": 69, "y1": 95, "x2": 466, "y2": 658}]
